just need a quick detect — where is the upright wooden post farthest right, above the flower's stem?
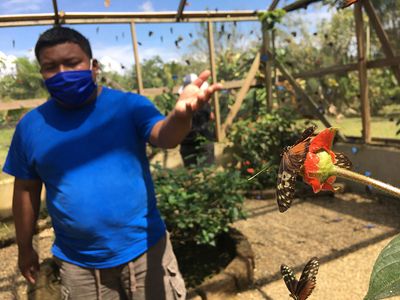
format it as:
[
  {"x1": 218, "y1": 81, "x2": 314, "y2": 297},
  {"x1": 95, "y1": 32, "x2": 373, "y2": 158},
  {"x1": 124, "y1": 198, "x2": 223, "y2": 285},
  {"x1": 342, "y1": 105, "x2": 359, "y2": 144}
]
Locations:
[{"x1": 354, "y1": 2, "x2": 371, "y2": 143}]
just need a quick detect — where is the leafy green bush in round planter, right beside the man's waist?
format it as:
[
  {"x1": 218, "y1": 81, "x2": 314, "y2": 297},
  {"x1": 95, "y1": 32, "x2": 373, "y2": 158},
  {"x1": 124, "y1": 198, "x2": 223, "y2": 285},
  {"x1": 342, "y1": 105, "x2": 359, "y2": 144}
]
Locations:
[{"x1": 153, "y1": 165, "x2": 246, "y2": 245}]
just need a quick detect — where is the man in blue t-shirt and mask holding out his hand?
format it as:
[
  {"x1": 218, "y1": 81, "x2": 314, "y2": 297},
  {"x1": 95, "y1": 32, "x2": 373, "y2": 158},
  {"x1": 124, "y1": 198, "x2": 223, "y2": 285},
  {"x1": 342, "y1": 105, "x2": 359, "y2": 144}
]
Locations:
[{"x1": 3, "y1": 27, "x2": 221, "y2": 300}]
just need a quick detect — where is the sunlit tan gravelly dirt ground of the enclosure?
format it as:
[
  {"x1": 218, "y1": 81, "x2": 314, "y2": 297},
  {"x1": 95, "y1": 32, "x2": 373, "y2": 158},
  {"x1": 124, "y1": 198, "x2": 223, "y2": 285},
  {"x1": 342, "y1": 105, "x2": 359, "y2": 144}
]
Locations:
[{"x1": 0, "y1": 193, "x2": 400, "y2": 300}]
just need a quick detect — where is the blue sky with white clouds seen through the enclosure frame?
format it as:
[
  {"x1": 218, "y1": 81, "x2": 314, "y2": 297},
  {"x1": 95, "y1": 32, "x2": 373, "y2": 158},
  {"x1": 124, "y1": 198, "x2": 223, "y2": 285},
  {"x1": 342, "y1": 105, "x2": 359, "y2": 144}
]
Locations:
[{"x1": 0, "y1": 0, "x2": 330, "y2": 71}]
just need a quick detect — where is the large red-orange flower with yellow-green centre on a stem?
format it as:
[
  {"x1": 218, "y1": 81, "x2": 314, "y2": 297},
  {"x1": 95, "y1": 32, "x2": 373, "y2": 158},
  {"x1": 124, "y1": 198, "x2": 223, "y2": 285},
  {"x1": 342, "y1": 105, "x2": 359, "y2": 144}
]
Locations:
[{"x1": 303, "y1": 128, "x2": 336, "y2": 193}]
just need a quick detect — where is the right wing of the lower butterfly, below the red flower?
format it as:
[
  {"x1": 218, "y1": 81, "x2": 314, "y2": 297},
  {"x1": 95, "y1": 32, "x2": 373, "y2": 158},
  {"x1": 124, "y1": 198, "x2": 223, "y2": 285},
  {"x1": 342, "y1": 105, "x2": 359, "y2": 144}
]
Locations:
[{"x1": 295, "y1": 257, "x2": 319, "y2": 300}]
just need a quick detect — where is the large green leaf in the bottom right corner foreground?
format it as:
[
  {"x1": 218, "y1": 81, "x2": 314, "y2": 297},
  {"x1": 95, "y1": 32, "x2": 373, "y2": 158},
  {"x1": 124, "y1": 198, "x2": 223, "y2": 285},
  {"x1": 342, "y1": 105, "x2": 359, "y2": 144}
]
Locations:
[{"x1": 364, "y1": 235, "x2": 400, "y2": 300}]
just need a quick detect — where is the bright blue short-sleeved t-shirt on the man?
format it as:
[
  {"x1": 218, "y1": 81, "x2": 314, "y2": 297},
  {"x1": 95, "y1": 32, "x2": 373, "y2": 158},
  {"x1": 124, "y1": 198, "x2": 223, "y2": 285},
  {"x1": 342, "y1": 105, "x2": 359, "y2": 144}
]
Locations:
[{"x1": 3, "y1": 88, "x2": 165, "y2": 268}]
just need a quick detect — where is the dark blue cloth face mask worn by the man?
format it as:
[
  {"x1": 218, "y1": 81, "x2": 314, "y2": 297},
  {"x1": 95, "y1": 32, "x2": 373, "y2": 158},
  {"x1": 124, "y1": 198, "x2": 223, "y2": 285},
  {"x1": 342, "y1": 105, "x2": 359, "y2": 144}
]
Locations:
[{"x1": 44, "y1": 70, "x2": 96, "y2": 106}]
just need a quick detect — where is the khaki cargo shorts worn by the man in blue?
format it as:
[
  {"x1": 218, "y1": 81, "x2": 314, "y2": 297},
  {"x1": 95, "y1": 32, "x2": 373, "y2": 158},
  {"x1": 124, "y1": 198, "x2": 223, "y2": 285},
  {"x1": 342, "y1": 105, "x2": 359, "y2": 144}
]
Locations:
[{"x1": 55, "y1": 234, "x2": 186, "y2": 300}]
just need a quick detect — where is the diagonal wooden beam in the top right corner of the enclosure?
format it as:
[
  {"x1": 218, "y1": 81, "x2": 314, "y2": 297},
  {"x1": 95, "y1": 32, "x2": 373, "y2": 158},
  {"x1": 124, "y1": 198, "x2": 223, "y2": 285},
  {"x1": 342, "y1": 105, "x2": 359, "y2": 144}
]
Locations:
[{"x1": 361, "y1": 0, "x2": 400, "y2": 84}]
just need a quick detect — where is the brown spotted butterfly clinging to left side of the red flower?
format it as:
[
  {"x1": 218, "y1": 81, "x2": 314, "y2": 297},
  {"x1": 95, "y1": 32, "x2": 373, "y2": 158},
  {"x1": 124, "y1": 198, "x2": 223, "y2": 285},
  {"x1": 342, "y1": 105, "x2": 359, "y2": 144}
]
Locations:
[{"x1": 276, "y1": 126, "x2": 316, "y2": 212}]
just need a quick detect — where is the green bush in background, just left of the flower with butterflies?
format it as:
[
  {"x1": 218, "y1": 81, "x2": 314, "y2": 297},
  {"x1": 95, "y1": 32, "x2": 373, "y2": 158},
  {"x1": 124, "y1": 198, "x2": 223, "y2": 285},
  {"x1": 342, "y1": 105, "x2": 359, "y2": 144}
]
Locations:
[{"x1": 227, "y1": 109, "x2": 300, "y2": 189}]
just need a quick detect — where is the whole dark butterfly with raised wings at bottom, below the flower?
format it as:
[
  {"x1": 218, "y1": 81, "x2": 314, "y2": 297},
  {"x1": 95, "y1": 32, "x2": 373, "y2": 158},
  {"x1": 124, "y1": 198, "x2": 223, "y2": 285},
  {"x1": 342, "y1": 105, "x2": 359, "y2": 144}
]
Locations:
[{"x1": 281, "y1": 257, "x2": 319, "y2": 300}]
